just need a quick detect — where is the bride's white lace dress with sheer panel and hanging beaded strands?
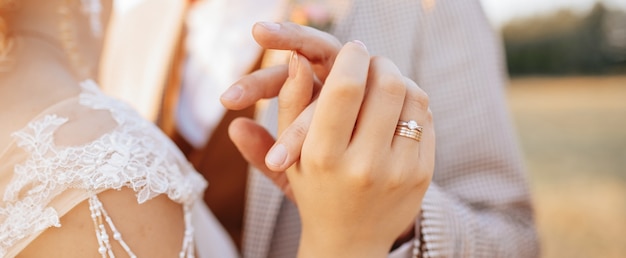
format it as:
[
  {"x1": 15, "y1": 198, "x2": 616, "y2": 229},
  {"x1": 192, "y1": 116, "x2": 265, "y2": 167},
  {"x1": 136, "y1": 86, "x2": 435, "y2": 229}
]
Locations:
[{"x1": 0, "y1": 81, "x2": 236, "y2": 257}]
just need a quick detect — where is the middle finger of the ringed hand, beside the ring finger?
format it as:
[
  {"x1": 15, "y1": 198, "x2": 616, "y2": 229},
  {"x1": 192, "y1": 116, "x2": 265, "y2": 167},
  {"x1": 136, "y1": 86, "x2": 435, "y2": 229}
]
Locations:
[{"x1": 352, "y1": 57, "x2": 406, "y2": 149}]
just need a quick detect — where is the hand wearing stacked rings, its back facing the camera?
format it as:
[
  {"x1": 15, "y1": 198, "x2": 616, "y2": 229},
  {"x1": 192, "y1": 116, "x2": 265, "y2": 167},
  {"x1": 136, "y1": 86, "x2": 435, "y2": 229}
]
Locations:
[{"x1": 286, "y1": 42, "x2": 435, "y2": 257}]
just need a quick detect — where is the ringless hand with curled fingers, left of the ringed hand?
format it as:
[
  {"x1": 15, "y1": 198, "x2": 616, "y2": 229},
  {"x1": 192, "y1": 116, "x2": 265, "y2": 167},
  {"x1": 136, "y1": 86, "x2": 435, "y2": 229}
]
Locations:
[{"x1": 222, "y1": 23, "x2": 434, "y2": 252}]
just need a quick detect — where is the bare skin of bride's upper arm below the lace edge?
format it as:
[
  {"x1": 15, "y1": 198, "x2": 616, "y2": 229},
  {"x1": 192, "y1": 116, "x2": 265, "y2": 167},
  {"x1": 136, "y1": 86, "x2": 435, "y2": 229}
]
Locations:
[{"x1": 20, "y1": 188, "x2": 185, "y2": 257}]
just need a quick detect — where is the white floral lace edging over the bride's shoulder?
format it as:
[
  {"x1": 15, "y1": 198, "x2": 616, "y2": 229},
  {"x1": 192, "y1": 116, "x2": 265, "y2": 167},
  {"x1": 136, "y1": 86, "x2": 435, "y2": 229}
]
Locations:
[{"x1": 0, "y1": 81, "x2": 207, "y2": 257}]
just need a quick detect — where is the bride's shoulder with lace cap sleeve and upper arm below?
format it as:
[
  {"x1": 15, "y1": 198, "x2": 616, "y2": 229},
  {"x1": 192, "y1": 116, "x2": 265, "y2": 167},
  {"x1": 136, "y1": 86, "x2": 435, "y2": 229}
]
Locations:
[{"x1": 3, "y1": 84, "x2": 206, "y2": 257}]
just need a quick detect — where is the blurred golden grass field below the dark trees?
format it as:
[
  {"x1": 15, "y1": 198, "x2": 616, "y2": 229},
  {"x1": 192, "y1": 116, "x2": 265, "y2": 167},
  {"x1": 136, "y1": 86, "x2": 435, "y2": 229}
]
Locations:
[{"x1": 508, "y1": 76, "x2": 626, "y2": 258}]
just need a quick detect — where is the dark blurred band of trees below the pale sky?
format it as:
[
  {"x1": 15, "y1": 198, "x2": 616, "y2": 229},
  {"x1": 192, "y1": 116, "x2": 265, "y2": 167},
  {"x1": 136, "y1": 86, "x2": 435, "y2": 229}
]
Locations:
[{"x1": 502, "y1": 3, "x2": 626, "y2": 76}]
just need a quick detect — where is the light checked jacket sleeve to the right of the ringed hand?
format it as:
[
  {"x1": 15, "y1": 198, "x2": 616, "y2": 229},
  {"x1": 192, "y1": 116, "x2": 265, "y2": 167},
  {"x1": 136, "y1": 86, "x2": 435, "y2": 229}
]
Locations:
[{"x1": 391, "y1": 0, "x2": 539, "y2": 257}]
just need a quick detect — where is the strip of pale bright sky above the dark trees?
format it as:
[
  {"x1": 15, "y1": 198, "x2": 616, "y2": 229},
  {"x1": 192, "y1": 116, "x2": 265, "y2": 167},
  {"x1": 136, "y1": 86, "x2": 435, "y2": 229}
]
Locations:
[{"x1": 480, "y1": 0, "x2": 626, "y2": 27}]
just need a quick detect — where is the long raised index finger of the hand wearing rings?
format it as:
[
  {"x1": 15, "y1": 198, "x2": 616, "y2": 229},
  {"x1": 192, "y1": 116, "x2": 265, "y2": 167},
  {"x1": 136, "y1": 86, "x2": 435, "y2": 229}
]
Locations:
[{"x1": 303, "y1": 41, "x2": 370, "y2": 158}]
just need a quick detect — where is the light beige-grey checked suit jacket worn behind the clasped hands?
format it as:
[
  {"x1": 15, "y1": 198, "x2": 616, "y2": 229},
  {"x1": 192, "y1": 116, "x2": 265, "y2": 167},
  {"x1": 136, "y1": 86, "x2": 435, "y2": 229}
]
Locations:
[{"x1": 243, "y1": 0, "x2": 539, "y2": 258}]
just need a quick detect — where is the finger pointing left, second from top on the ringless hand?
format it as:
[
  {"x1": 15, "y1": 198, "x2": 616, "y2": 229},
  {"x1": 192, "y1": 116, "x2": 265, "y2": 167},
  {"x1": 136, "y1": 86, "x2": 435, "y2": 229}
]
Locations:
[{"x1": 220, "y1": 65, "x2": 288, "y2": 110}]
